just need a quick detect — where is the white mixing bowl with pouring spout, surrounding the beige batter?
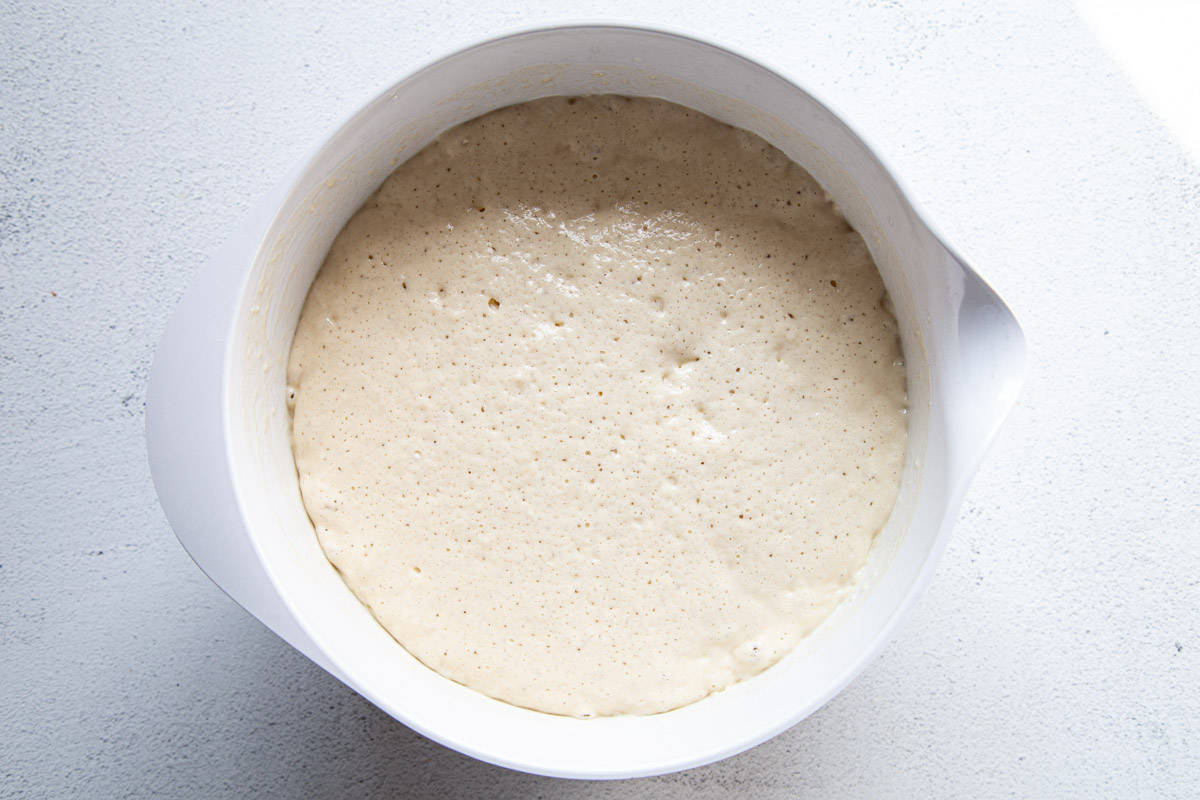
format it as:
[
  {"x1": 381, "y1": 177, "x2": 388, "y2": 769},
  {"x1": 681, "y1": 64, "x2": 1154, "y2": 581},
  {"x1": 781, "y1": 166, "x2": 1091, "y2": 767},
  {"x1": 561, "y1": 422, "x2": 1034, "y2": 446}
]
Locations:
[{"x1": 146, "y1": 25, "x2": 1025, "y2": 777}]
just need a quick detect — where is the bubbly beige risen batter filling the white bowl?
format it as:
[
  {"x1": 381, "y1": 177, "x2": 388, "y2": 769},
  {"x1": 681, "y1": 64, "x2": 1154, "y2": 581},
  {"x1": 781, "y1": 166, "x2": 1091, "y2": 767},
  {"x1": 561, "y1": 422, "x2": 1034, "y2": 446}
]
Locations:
[{"x1": 288, "y1": 96, "x2": 906, "y2": 716}]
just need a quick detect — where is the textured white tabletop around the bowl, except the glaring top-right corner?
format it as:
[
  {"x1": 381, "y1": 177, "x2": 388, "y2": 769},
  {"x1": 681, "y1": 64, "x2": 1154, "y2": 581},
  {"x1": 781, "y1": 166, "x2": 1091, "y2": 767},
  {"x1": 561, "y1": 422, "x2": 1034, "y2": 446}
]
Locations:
[{"x1": 0, "y1": 0, "x2": 1200, "y2": 799}]
